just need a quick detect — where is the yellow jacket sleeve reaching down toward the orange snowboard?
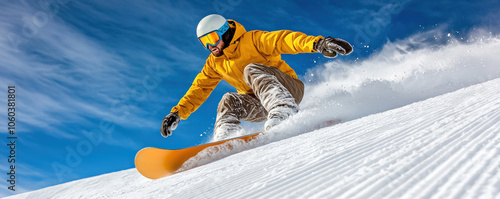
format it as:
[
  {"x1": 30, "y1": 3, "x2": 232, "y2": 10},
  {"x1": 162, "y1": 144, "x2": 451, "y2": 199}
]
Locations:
[{"x1": 171, "y1": 58, "x2": 222, "y2": 120}]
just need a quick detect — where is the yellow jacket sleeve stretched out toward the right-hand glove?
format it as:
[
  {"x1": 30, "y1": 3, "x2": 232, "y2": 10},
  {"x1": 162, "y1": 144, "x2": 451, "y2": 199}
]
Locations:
[{"x1": 253, "y1": 30, "x2": 324, "y2": 55}]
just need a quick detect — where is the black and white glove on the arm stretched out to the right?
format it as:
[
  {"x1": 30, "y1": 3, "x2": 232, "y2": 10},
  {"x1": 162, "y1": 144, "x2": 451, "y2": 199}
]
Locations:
[{"x1": 314, "y1": 37, "x2": 352, "y2": 58}]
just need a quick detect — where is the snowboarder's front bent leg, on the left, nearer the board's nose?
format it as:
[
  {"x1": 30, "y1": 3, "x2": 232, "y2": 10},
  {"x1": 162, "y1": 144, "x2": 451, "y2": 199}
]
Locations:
[{"x1": 214, "y1": 93, "x2": 267, "y2": 140}]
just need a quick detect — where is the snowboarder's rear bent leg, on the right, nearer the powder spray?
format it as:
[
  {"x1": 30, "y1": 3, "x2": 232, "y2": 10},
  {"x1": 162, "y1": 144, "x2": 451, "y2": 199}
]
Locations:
[{"x1": 243, "y1": 63, "x2": 304, "y2": 130}]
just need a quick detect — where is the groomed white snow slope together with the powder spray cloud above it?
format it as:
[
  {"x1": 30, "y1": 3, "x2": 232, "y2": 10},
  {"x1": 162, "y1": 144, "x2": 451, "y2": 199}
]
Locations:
[{"x1": 4, "y1": 30, "x2": 500, "y2": 198}]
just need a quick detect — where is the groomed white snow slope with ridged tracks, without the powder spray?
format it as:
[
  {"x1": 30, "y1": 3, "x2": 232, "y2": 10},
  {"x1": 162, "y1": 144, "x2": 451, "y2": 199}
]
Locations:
[{"x1": 9, "y1": 79, "x2": 500, "y2": 198}]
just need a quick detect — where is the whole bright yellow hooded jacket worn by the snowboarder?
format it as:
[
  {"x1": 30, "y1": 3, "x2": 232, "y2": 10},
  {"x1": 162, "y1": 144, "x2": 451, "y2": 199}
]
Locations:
[{"x1": 172, "y1": 20, "x2": 323, "y2": 119}]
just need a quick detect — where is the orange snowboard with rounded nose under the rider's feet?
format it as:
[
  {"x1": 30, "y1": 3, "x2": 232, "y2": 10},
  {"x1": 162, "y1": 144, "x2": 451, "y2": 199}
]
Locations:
[{"x1": 135, "y1": 133, "x2": 262, "y2": 179}]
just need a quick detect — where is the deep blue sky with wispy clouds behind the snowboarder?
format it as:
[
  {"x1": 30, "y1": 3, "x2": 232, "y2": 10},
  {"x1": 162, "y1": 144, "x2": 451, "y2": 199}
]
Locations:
[{"x1": 0, "y1": 0, "x2": 500, "y2": 195}]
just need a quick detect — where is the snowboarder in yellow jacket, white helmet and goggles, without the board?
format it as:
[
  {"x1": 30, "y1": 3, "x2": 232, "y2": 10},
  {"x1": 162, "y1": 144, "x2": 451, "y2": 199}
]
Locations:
[{"x1": 161, "y1": 14, "x2": 352, "y2": 140}]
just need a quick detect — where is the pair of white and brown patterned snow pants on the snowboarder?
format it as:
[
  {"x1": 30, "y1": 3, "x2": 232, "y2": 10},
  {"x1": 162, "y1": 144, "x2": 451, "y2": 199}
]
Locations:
[{"x1": 214, "y1": 63, "x2": 304, "y2": 140}]
